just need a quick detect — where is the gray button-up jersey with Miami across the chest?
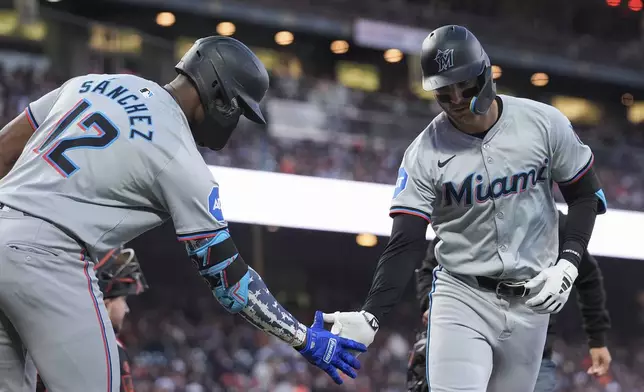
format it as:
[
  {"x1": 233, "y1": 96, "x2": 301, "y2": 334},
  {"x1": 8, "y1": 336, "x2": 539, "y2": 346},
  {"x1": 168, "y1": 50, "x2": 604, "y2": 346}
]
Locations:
[{"x1": 391, "y1": 95, "x2": 593, "y2": 279}]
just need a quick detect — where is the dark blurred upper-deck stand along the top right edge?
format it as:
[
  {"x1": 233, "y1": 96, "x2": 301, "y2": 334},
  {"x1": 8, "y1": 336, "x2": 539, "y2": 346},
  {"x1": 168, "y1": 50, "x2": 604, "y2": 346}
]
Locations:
[{"x1": 243, "y1": 0, "x2": 644, "y2": 70}]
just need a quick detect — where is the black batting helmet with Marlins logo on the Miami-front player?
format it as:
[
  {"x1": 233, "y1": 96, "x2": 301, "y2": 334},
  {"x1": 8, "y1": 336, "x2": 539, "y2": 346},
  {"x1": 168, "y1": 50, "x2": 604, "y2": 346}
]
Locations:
[{"x1": 420, "y1": 25, "x2": 496, "y2": 114}]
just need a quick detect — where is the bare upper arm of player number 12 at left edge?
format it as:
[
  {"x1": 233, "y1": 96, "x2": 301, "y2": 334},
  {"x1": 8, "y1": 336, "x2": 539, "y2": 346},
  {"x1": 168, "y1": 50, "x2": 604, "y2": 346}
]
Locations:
[{"x1": 0, "y1": 112, "x2": 34, "y2": 179}]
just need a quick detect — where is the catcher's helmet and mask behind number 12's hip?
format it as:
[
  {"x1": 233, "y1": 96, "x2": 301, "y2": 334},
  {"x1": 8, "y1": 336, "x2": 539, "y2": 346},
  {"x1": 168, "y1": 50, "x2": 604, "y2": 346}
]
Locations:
[{"x1": 94, "y1": 248, "x2": 148, "y2": 299}]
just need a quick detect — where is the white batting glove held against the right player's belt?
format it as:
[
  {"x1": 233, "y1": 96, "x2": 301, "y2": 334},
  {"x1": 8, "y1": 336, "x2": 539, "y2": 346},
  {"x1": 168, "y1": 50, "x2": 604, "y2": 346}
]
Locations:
[{"x1": 525, "y1": 259, "x2": 578, "y2": 314}]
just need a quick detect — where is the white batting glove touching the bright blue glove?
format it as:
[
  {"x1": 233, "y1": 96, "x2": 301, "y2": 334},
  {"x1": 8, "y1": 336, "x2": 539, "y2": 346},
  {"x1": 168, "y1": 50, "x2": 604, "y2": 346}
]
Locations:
[{"x1": 324, "y1": 310, "x2": 380, "y2": 356}]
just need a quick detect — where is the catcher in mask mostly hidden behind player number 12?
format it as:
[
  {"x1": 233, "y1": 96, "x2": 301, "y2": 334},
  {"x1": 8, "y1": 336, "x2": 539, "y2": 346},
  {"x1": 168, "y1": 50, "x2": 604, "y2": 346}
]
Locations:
[{"x1": 36, "y1": 248, "x2": 148, "y2": 392}]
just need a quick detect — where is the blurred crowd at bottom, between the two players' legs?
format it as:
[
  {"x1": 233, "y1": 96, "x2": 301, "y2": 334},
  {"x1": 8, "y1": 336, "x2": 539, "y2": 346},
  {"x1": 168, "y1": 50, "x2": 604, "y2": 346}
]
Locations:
[{"x1": 122, "y1": 298, "x2": 410, "y2": 392}]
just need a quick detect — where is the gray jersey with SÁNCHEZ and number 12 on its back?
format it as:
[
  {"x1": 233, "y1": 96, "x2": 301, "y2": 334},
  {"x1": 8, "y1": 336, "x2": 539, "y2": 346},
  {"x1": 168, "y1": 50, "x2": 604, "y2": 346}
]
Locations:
[{"x1": 0, "y1": 74, "x2": 226, "y2": 252}]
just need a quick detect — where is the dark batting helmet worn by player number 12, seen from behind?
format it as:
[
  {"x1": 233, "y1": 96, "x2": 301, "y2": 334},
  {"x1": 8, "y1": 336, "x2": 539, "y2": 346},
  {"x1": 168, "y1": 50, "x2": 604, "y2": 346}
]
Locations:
[{"x1": 175, "y1": 36, "x2": 268, "y2": 150}]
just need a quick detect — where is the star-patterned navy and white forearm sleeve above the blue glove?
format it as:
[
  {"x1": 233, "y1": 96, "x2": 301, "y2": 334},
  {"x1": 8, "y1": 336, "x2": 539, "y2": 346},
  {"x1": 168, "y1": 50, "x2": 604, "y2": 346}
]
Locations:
[{"x1": 239, "y1": 268, "x2": 306, "y2": 347}]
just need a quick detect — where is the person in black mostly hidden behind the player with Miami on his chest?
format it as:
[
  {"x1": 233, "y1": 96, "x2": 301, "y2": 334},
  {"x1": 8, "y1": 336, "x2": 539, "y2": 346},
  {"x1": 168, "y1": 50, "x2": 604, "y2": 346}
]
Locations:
[{"x1": 407, "y1": 212, "x2": 611, "y2": 392}]
